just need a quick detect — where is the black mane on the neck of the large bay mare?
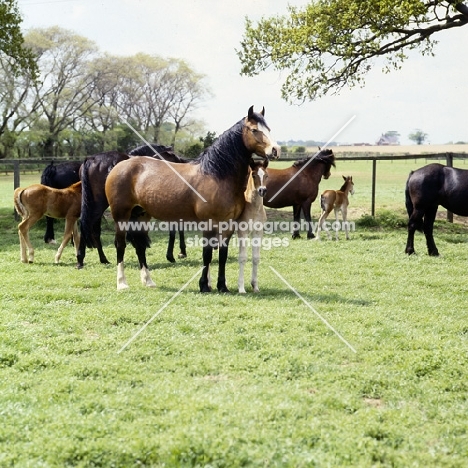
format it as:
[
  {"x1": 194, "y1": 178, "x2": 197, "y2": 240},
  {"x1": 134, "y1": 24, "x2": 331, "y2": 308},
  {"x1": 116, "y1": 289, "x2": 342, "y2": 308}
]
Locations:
[{"x1": 192, "y1": 114, "x2": 254, "y2": 179}]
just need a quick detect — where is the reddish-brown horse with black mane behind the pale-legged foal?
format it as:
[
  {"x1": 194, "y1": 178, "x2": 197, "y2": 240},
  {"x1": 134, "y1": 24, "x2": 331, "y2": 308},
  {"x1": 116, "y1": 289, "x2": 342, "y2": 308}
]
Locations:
[{"x1": 263, "y1": 149, "x2": 335, "y2": 239}]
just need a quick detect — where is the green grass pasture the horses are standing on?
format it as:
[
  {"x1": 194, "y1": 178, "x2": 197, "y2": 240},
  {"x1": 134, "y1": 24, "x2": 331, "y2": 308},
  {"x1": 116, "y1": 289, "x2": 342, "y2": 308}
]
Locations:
[{"x1": 0, "y1": 160, "x2": 468, "y2": 467}]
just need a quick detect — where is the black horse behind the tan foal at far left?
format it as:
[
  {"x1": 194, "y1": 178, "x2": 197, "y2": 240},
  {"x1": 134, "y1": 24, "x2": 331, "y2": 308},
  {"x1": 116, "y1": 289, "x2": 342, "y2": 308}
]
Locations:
[{"x1": 41, "y1": 161, "x2": 81, "y2": 244}]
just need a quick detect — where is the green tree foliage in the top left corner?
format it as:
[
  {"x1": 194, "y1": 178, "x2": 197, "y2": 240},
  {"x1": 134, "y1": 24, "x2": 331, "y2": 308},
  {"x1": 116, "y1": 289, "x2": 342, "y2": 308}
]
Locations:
[{"x1": 0, "y1": 0, "x2": 37, "y2": 78}]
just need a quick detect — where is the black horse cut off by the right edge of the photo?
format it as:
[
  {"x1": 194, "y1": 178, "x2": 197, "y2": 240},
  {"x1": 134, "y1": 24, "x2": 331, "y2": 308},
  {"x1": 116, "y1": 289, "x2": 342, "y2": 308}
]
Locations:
[{"x1": 405, "y1": 163, "x2": 468, "y2": 256}]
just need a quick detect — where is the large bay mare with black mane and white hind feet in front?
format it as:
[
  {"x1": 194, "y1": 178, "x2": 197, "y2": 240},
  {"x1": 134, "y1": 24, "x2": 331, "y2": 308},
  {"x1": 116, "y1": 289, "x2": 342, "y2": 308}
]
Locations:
[{"x1": 106, "y1": 106, "x2": 280, "y2": 292}]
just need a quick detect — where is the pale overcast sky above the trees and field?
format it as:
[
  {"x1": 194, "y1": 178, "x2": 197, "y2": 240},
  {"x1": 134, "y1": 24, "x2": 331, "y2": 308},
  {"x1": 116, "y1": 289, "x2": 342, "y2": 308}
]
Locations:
[{"x1": 18, "y1": 0, "x2": 468, "y2": 144}]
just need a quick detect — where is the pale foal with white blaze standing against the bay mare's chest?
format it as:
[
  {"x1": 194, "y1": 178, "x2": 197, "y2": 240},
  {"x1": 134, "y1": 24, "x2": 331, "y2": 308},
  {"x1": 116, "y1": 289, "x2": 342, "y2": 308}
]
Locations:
[{"x1": 237, "y1": 160, "x2": 268, "y2": 294}]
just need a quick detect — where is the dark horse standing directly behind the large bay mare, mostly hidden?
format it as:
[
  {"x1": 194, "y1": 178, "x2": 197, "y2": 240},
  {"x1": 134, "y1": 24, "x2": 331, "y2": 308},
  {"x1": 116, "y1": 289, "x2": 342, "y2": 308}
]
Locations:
[{"x1": 77, "y1": 144, "x2": 187, "y2": 268}]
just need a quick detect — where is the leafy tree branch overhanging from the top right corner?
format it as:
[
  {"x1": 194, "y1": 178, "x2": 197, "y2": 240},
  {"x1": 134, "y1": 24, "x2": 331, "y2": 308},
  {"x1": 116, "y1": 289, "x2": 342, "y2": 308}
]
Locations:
[{"x1": 237, "y1": 0, "x2": 468, "y2": 102}]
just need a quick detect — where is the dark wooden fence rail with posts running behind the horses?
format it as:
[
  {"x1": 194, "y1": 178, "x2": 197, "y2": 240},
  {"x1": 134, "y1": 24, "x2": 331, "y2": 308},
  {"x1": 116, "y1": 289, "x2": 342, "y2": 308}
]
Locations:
[{"x1": 0, "y1": 152, "x2": 468, "y2": 222}]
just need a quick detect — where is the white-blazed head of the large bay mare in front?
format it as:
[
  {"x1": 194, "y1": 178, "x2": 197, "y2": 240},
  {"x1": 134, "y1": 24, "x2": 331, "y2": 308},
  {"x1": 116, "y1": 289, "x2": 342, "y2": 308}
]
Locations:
[{"x1": 242, "y1": 106, "x2": 281, "y2": 163}]
